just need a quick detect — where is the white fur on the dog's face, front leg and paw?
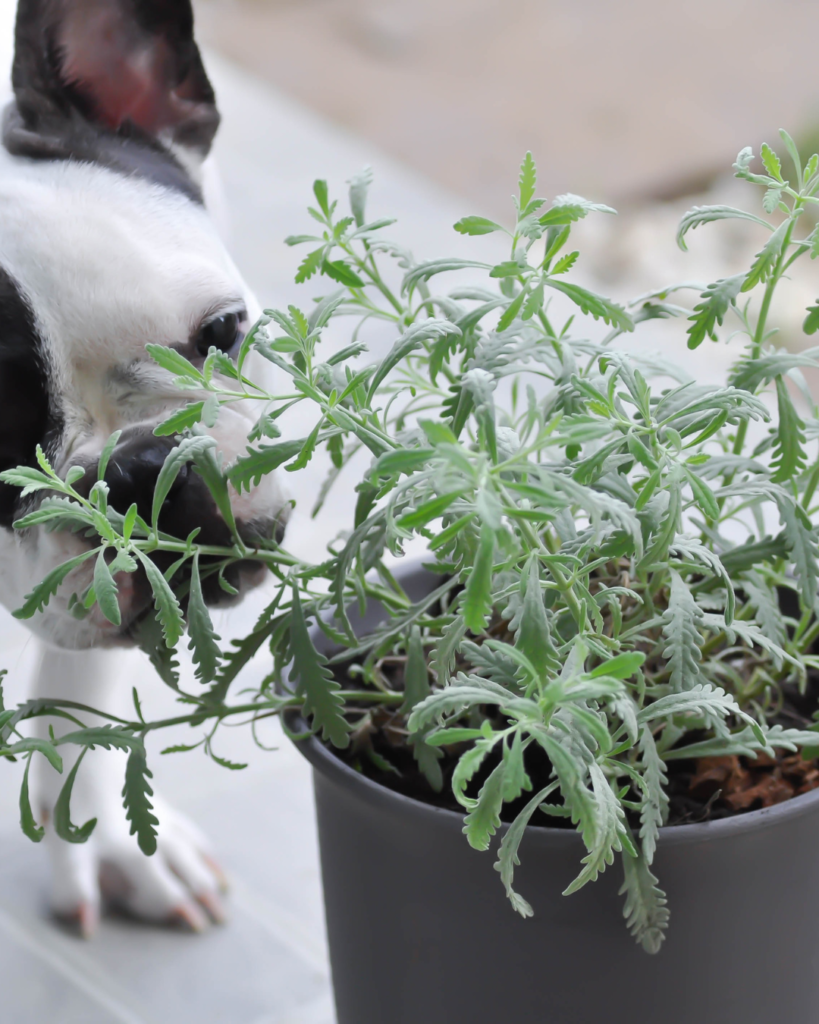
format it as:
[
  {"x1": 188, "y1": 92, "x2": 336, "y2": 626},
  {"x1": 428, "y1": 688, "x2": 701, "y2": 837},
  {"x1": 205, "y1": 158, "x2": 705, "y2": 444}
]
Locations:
[{"x1": 0, "y1": 4, "x2": 282, "y2": 934}]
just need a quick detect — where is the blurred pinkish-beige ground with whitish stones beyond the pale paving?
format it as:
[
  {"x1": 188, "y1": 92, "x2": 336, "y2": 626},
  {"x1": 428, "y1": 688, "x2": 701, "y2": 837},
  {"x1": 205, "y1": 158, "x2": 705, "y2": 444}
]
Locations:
[{"x1": 196, "y1": 0, "x2": 819, "y2": 347}]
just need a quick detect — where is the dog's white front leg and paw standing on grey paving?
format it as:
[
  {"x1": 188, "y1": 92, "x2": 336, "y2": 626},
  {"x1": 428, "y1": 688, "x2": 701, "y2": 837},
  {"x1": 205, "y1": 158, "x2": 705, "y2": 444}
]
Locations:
[{"x1": 34, "y1": 648, "x2": 224, "y2": 935}]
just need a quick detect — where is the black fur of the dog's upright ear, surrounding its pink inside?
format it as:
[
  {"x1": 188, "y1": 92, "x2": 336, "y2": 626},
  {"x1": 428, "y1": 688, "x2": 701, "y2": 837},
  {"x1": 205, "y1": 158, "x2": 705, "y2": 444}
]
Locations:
[{"x1": 3, "y1": 0, "x2": 219, "y2": 202}]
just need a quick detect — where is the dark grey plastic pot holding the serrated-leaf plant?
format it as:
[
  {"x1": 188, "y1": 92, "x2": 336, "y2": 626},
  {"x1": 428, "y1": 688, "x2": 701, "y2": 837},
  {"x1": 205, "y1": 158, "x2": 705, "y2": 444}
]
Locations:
[{"x1": 288, "y1": 569, "x2": 819, "y2": 1024}]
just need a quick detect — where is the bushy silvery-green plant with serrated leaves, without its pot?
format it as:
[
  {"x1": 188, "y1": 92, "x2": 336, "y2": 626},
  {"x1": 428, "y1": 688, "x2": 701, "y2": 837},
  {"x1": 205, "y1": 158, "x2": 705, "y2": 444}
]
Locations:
[{"x1": 0, "y1": 132, "x2": 819, "y2": 952}]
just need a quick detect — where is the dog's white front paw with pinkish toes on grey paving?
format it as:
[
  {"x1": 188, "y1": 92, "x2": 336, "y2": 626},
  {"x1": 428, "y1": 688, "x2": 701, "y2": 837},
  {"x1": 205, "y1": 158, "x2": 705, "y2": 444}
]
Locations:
[{"x1": 45, "y1": 801, "x2": 227, "y2": 938}]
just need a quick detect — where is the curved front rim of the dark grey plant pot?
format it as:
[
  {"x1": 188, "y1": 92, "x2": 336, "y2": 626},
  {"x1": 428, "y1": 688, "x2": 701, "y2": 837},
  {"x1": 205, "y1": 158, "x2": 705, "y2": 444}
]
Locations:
[{"x1": 288, "y1": 713, "x2": 819, "y2": 847}]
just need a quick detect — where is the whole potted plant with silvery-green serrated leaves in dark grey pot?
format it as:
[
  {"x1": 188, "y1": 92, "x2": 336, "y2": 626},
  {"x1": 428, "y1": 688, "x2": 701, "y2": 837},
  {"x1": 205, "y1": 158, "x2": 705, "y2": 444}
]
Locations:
[{"x1": 0, "y1": 133, "x2": 819, "y2": 1024}]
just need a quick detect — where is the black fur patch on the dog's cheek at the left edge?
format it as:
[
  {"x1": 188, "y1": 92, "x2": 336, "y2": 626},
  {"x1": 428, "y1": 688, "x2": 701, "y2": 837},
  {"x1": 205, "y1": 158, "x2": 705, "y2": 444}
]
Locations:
[{"x1": 0, "y1": 267, "x2": 59, "y2": 527}]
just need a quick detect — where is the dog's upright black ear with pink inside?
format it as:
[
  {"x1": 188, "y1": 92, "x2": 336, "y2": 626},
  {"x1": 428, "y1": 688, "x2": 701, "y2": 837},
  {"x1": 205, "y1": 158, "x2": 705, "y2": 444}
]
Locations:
[{"x1": 4, "y1": 0, "x2": 219, "y2": 163}]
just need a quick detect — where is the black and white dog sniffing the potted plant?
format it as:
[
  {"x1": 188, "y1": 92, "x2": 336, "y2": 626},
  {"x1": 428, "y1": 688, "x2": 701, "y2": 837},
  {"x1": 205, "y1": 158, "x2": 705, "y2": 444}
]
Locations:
[{"x1": 0, "y1": 0, "x2": 283, "y2": 933}]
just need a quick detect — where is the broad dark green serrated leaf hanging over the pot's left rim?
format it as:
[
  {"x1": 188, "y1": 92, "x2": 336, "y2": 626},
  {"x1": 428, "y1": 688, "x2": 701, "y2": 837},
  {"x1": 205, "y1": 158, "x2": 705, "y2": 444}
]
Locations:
[{"x1": 290, "y1": 587, "x2": 350, "y2": 749}]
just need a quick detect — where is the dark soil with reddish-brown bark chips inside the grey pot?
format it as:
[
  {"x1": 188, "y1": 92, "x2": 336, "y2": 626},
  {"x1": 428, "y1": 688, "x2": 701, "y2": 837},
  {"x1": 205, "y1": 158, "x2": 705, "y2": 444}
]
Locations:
[{"x1": 333, "y1": 659, "x2": 819, "y2": 828}]
